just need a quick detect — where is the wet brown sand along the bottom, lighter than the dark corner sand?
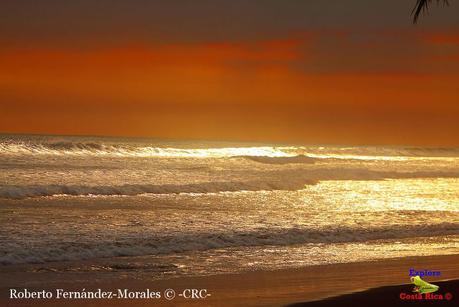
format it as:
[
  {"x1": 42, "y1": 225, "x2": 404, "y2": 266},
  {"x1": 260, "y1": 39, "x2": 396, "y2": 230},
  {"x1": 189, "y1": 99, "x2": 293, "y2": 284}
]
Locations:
[{"x1": 0, "y1": 255, "x2": 459, "y2": 306}]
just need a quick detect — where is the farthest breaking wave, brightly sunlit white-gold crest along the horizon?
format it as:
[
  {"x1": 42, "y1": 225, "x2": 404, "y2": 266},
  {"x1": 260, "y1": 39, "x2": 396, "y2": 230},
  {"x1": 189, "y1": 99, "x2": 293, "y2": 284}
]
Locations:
[{"x1": 0, "y1": 137, "x2": 459, "y2": 160}]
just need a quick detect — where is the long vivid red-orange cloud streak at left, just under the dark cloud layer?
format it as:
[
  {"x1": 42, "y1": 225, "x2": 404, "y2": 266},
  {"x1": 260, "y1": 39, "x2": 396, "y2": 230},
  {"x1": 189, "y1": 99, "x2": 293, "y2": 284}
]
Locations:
[{"x1": 0, "y1": 35, "x2": 310, "y2": 73}]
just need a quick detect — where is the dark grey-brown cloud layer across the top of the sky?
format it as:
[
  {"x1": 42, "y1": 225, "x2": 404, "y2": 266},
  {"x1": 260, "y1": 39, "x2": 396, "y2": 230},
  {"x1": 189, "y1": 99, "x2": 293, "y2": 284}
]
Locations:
[{"x1": 0, "y1": 0, "x2": 459, "y2": 46}]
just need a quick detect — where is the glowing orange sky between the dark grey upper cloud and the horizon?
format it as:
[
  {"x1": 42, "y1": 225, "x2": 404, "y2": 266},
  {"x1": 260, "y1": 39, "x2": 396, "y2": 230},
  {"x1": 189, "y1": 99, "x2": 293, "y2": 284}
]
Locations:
[{"x1": 0, "y1": 1, "x2": 459, "y2": 146}]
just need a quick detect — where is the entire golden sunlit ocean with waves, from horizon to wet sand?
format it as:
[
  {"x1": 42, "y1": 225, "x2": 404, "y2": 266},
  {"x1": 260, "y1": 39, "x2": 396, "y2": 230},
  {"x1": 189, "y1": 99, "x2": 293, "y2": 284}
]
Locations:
[{"x1": 0, "y1": 135, "x2": 459, "y2": 279}]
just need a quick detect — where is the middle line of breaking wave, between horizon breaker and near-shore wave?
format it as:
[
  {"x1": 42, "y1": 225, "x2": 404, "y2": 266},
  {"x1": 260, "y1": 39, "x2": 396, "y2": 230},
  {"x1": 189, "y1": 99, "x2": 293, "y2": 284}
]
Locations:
[{"x1": 0, "y1": 168, "x2": 459, "y2": 199}]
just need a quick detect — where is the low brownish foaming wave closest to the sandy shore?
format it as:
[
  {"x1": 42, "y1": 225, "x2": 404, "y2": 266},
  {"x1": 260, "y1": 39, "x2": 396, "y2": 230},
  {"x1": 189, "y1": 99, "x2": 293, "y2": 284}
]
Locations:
[{"x1": 0, "y1": 223, "x2": 459, "y2": 265}]
